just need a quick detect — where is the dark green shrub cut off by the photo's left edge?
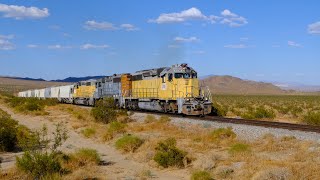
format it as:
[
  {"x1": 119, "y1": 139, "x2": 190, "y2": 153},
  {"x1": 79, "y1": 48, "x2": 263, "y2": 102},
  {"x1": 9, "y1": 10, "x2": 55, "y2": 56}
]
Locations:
[{"x1": 0, "y1": 109, "x2": 18, "y2": 151}]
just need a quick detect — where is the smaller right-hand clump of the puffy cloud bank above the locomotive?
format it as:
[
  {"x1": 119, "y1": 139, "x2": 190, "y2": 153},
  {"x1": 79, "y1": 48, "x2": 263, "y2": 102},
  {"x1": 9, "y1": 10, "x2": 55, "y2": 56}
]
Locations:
[{"x1": 220, "y1": 9, "x2": 248, "y2": 27}]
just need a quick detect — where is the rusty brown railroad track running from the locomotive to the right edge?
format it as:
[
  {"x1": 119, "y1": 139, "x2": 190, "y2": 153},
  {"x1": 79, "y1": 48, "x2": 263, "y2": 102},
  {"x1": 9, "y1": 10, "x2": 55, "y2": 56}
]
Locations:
[{"x1": 139, "y1": 111, "x2": 320, "y2": 133}]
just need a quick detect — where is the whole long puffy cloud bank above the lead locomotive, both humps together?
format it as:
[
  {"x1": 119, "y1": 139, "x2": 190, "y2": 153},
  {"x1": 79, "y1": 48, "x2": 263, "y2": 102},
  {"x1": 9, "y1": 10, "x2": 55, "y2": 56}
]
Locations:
[{"x1": 148, "y1": 7, "x2": 248, "y2": 27}]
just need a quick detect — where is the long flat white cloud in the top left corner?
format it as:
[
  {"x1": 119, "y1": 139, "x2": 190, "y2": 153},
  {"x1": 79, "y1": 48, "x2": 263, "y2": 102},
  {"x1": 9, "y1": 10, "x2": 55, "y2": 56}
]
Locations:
[{"x1": 0, "y1": 4, "x2": 50, "y2": 19}]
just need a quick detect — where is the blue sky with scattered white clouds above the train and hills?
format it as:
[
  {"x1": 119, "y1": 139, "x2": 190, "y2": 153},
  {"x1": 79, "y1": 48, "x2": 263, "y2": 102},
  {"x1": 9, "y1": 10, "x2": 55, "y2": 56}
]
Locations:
[{"x1": 0, "y1": 0, "x2": 320, "y2": 85}]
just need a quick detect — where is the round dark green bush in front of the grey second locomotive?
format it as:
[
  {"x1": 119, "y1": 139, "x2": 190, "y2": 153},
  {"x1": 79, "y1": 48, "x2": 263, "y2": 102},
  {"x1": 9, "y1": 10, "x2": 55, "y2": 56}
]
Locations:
[{"x1": 91, "y1": 98, "x2": 117, "y2": 124}]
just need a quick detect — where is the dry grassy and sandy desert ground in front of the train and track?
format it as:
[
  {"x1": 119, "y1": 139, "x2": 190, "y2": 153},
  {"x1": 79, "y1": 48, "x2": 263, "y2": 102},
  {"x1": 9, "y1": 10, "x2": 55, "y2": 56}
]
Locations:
[{"x1": 0, "y1": 95, "x2": 320, "y2": 179}]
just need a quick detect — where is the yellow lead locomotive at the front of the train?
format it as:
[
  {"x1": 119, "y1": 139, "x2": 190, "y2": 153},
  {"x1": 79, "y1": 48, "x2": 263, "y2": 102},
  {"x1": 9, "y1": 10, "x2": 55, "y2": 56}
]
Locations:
[{"x1": 119, "y1": 64, "x2": 212, "y2": 115}]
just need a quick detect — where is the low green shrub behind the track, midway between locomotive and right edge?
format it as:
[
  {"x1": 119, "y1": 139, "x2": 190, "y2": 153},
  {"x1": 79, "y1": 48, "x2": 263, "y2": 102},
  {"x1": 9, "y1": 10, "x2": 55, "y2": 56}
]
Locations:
[{"x1": 241, "y1": 107, "x2": 276, "y2": 119}]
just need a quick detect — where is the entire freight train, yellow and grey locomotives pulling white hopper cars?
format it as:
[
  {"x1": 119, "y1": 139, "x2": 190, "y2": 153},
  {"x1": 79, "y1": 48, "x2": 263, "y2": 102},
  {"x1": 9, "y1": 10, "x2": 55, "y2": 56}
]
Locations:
[{"x1": 18, "y1": 63, "x2": 212, "y2": 116}]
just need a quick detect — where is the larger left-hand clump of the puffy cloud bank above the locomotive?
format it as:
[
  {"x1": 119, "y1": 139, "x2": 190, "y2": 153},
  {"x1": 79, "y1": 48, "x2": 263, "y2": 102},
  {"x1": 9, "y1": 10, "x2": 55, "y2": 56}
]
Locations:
[{"x1": 149, "y1": 7, "x2": 207, "y2": 24}]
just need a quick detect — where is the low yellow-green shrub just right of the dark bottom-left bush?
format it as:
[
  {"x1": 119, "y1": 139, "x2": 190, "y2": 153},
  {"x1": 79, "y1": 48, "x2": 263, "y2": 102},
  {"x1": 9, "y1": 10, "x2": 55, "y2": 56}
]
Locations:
[{"x1": 67, "y1": 148, "x2": 101, "y2": 169}]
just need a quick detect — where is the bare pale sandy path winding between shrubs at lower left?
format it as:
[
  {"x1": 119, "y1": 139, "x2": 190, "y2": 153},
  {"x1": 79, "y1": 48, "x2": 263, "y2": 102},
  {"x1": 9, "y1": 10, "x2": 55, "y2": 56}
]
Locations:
[{"x1": 0, "y1": 104, "x2": 190, "y2": 179}]
